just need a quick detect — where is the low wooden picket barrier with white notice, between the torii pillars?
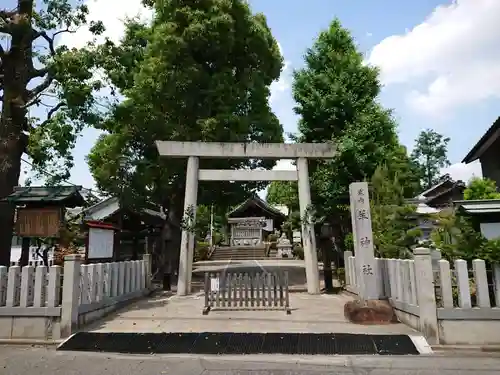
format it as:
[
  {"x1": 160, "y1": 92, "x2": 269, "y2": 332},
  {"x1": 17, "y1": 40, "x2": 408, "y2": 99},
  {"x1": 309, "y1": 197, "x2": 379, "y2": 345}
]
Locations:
[{"x1": 203, "y1": 271, "x2": 291, "y2": 315}]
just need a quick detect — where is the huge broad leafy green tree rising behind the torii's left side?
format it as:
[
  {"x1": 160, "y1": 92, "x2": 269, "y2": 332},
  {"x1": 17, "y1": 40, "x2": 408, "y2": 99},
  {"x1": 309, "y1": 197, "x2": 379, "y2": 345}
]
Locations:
[{"x1": 88, "y1": 0, "x2": 283, "y2": 282}]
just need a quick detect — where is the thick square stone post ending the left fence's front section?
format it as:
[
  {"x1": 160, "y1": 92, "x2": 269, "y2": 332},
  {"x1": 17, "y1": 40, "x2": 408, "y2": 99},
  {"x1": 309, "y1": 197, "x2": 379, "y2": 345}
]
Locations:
[{"x1": 61, "y1": 255, "x2": 82, "y2": 337}]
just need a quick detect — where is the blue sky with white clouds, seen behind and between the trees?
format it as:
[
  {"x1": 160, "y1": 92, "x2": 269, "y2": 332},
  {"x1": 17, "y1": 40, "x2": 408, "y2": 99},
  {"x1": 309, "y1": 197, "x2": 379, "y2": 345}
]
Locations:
[{"x1": 20, "y1": 0, "x2": 500, "y2": 187}]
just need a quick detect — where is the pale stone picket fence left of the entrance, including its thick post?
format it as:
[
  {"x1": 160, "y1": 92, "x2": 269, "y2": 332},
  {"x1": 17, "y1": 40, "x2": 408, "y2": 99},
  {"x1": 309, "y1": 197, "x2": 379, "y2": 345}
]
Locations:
[{"x1": 0, "y1": 254, "x2": 151, "y2": 340}]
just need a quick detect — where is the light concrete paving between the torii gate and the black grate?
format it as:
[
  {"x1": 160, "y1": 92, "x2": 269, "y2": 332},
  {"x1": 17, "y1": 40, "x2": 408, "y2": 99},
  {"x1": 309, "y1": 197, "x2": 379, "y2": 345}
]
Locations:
[{"x1": 86, "y1": 293, "x2": 420, "y2": 336}]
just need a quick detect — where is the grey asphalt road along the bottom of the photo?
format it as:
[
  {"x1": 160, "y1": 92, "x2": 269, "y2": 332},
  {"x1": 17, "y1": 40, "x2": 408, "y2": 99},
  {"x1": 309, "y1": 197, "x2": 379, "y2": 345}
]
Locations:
[{"x1": 0, "y1": 346, "x2": 500, "y2": 375}]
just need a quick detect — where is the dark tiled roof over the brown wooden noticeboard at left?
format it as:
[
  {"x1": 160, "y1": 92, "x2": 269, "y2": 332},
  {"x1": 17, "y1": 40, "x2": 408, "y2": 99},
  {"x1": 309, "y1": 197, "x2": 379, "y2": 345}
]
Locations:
[{"x1": 2, "y1": 186, "x2": 85, "y2": 207}]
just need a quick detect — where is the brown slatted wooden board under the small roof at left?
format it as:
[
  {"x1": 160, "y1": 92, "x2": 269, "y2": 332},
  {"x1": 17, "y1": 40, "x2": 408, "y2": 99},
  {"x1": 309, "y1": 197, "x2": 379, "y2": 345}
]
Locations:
[{"x1": 16, "y1": 207, "x2": 62, "y2": 237}]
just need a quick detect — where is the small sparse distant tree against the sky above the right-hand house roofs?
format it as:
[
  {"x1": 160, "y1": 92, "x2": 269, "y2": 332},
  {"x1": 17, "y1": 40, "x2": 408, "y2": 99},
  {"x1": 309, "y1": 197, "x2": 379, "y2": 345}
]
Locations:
[{"x1": 411, "y1": 129, "x2": 450, "y2": 190}]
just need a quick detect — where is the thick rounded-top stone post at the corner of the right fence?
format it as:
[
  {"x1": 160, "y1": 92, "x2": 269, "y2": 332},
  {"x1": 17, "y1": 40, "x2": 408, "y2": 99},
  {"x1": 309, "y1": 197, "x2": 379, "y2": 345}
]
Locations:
[{"x1": 413, "y1": 247, "x2": 439, "y2": 345}]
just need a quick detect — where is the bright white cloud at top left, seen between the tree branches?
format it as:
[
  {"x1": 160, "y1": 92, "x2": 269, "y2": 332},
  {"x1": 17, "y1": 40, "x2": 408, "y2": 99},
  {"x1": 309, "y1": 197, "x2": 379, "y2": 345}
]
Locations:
[{"x1": 58, "y1": 0, "x2": 152, "y2": 48}]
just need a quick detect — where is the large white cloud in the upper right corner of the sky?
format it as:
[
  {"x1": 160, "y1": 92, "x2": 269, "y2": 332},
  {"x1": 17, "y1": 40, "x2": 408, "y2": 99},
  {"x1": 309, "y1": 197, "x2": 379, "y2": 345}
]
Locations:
[{"x1": 368, "y1": 0, "x2": 500, "y2": 115}]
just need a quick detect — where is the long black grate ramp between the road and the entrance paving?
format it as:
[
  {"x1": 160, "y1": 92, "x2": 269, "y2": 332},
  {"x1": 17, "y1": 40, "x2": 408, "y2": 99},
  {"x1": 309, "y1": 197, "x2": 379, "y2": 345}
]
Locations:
[{"x1": 58, "y1": 332, "x2": 419, "y2": 355}]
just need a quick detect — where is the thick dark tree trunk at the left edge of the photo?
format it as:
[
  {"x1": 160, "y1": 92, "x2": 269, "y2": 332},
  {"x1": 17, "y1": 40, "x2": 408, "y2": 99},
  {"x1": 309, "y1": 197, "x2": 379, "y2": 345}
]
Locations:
[{"x1": 0, "y1": 0, "x2": 33, "y2": 266}]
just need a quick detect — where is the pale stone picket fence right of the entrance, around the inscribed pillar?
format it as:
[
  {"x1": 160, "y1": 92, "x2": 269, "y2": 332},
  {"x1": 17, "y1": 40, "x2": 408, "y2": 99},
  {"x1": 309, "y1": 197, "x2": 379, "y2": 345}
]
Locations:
[{"x1": 344, "y1": 248, "x2": 500, "y2": 345}]
